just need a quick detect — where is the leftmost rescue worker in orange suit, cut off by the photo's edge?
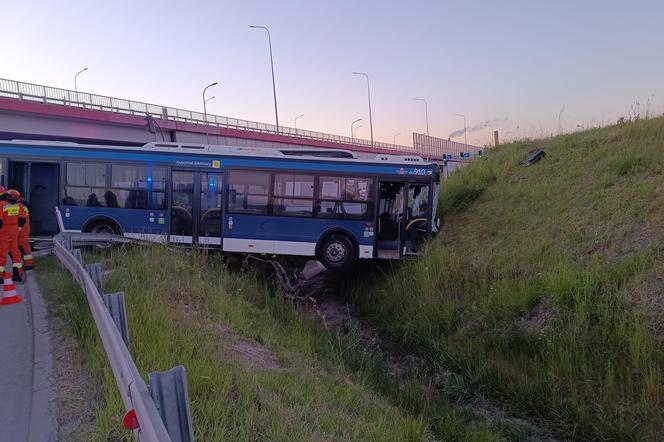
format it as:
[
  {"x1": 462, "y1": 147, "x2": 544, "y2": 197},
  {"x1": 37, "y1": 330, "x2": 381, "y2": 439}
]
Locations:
[{"x1": 0, "y1": 186, "x2": 25, "y2": 282}]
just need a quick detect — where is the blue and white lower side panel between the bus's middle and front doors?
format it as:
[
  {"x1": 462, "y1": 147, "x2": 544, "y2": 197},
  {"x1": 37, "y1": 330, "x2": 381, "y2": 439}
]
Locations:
[{"x1": 224, "y1": 214, "x2": 374, "y2": 258}]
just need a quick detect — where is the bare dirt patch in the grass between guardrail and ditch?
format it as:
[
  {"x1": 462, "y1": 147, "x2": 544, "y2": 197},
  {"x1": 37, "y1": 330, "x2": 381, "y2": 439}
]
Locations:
[{"x1": 219, "y1": 324, "x2": 283, "y2": 371}]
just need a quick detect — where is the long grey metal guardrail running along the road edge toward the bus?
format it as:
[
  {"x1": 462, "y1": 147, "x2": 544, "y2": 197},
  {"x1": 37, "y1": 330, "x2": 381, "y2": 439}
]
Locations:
[{"x1": 53, "y1": 232, "x2": 193, "y2": 442}]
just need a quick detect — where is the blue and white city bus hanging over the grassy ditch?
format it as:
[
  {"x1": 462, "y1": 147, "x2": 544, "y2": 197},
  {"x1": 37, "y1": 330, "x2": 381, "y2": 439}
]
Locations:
[{"x1": 0, "y1": 141, "x2": 440, "y2": 268}]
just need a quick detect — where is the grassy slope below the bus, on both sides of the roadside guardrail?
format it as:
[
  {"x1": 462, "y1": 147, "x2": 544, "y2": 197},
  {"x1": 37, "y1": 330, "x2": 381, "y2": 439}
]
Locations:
[{"x1": 38, "y1": 247, "x2": 522, "y2": 441}]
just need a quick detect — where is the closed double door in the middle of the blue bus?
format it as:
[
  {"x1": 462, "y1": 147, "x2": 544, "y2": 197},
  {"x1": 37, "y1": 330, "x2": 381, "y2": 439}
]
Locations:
[{"x1": 170, "y1": 171, "x2": 223, "y2": 247}]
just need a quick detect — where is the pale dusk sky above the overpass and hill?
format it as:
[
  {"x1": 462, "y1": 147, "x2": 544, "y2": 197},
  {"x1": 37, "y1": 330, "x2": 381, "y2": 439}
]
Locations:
[{"x1": 0, "y1": 0, "x2": 664, "y2": 145}]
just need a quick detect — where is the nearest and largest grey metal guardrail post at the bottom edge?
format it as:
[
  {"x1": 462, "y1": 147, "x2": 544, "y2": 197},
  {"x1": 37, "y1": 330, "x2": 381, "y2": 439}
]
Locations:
[{"x1": 148, "y1": 365, "x2": 194, "y2": 442}]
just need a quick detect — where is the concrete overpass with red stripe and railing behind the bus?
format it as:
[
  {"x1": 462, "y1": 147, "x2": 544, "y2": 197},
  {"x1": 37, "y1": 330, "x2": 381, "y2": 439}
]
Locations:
[{"x1": 0, "y1": 79, "x2": 481, "y2": 160}]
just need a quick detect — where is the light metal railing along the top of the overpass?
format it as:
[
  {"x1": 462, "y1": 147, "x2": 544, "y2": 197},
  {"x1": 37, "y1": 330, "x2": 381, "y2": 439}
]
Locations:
[{"x1": 0, "y1": 78, "x2": 420, "y2": 153}]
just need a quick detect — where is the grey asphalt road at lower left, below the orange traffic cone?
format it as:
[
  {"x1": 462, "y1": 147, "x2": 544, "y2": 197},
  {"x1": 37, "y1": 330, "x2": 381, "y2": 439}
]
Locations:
[{"x1": 0, "y1": 272, "x2": 57, "y2": 442}]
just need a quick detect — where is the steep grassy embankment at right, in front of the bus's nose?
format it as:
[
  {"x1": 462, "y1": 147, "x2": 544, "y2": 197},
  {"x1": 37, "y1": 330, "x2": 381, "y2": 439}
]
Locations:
[{"x1": 358, "y1": 118, "x2": 664, "y2": 441}]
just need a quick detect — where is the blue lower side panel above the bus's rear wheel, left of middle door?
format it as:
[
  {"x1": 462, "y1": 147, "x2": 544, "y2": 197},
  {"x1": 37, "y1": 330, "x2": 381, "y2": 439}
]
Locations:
[{"x1": 62, "y1": 206, "x2": 168, "y2": 241}]
